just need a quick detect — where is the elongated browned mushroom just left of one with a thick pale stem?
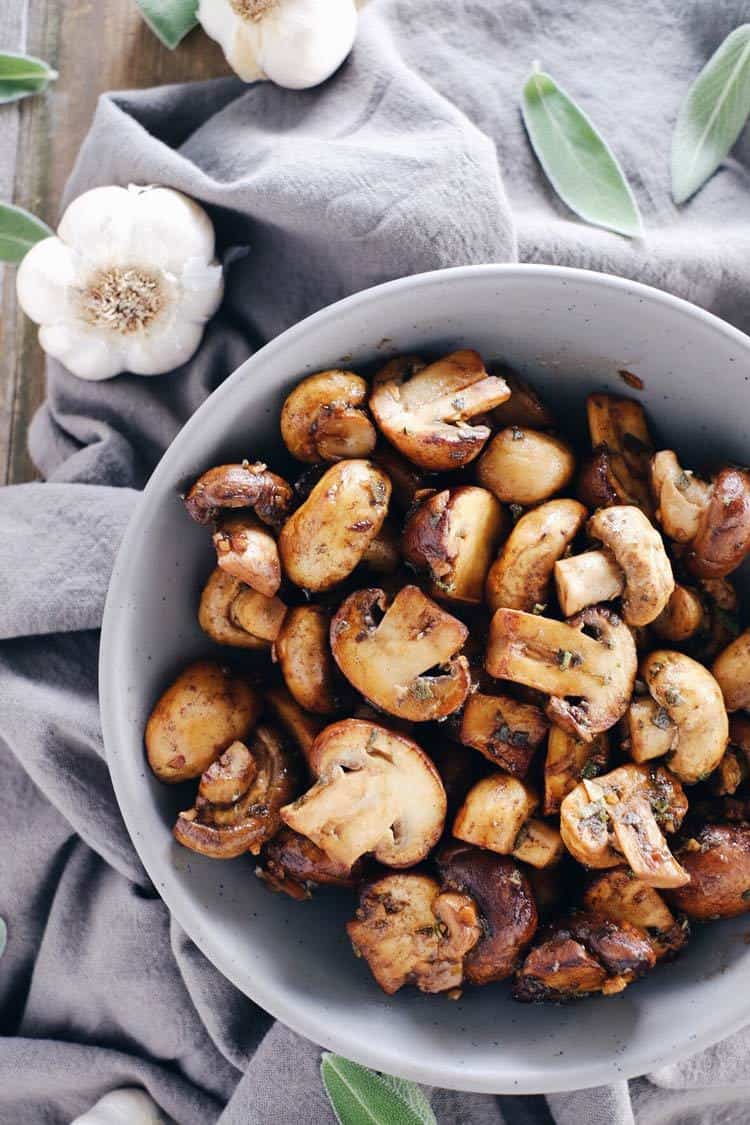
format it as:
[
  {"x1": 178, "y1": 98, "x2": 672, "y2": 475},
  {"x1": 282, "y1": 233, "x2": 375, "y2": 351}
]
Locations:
[{"x1": 486, "y1": 500, "x2": 586, "y2": 613}]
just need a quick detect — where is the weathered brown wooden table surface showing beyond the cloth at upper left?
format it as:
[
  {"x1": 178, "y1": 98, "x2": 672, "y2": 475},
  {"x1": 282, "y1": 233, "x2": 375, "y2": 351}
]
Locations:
[{"x1": 0, "y1": 0, "x2": 229, "y2": 484}]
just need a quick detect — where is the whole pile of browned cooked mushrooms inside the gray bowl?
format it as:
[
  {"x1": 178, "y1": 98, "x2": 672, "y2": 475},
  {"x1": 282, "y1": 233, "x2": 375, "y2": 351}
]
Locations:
[{"x1": 145, "y1": 350, "x2": 750, "y2": 1001}]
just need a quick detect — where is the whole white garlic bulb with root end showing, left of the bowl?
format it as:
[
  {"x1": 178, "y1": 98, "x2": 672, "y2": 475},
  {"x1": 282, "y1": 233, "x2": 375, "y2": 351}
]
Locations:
[{"x1": 16, "y1": 186, "x2": 224, "y2": 379}]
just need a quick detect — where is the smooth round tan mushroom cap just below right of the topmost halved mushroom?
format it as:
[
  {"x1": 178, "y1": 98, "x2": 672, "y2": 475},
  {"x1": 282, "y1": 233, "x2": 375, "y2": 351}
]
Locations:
[{"x1": 477, "y1": 426, "x2": 576, "y2": 506}]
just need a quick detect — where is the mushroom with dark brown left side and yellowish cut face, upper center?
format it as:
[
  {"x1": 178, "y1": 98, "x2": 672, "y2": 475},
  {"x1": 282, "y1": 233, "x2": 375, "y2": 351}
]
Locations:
[{"x1": 403, "y1": 485, "x2": 506, "y2": 605}]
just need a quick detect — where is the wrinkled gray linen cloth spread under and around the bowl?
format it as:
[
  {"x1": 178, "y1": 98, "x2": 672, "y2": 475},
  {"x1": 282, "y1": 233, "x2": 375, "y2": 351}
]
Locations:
[{"x1": 0, "y1": 0, "x2": 750, "y2": 1125}]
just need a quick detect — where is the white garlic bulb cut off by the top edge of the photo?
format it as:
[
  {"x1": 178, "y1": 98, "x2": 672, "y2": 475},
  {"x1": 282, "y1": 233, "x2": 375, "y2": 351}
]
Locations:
[{"x1": 198, "y1": 0, "x2": 356, "y2": 90}]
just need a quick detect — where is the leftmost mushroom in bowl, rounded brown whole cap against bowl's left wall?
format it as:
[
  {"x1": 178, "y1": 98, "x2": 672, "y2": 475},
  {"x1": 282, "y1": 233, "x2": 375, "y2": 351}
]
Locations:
[{"x1": 145, "y1": 660, "x2": 261, "y2": 783}]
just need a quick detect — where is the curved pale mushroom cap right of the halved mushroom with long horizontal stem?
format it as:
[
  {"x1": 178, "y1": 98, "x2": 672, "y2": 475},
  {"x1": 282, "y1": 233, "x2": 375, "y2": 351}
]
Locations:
[{"x1": 641, "y1": 649, "x2": 729, "y2": 784}]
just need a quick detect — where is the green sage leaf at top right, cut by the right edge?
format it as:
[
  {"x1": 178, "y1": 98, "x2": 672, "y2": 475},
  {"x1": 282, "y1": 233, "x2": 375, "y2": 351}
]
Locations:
[{"x1": 671, "y1": 24, "x2": 750, "y2": 204}]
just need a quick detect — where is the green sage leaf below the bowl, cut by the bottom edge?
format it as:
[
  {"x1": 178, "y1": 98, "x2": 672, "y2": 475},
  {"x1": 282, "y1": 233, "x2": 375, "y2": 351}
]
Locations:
[{"x1": 320, "y1": 1052, "x2": 437, "y2": 1125}]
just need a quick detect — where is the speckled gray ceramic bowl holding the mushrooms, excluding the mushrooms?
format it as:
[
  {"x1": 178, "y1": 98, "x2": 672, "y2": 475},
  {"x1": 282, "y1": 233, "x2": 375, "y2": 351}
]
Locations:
[{"x1": 101, "y1": 266, "x2": 750, "y2": 1094}]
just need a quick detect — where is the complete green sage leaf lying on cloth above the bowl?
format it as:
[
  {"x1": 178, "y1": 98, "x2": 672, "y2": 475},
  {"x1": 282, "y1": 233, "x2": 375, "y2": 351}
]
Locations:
[{"x1": 522, "y1": 70, "x2": 643, "y2": 239}]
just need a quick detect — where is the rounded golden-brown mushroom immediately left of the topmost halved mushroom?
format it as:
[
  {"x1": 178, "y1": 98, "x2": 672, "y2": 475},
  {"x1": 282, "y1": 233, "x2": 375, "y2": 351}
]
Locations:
[{"x1": 281, "y1": 370, "x2": 377, "y2": 462}]
